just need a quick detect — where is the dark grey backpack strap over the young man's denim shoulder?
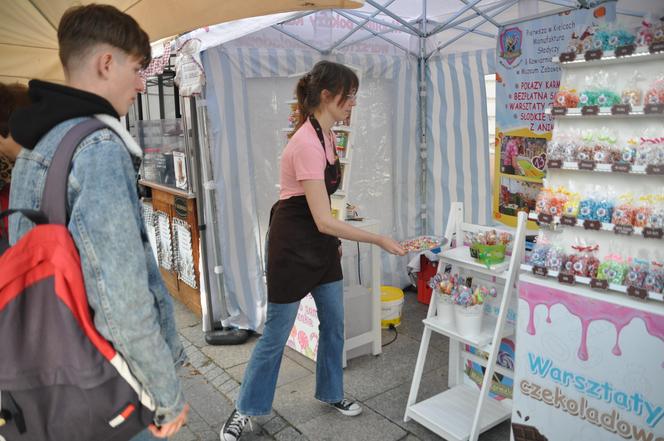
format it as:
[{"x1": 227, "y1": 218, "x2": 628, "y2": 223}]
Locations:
[{"x1": 41, "y1": 118, "x2": 112, "y2": 225}]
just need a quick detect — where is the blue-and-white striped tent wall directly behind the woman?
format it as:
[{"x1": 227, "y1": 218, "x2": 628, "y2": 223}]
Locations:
[{"x1": 202, "y1": 46, "x2": 420, "y2": 329}]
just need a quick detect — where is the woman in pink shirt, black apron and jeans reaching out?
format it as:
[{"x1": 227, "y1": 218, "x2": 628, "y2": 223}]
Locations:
[{"x1": 220, "y1": 61, "x2": 405, "y2": 441}]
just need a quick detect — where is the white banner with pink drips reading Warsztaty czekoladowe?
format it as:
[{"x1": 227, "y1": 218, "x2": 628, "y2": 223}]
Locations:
[{"x1": 512, "y1": 282, "x2": 664, "y2": 441}]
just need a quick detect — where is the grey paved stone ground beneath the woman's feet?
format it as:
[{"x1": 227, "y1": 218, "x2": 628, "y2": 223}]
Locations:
[{"x1": 171, "y1": 293, "x2": 509, "y2": 441}]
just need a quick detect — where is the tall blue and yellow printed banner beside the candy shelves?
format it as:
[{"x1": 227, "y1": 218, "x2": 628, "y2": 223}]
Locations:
[{"x1": 493, "y1": 2, "x2": 616, "y2": 228}]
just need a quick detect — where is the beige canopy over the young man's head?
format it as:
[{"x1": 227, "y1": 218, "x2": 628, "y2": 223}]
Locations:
[{"x1": 0, "y1": 0, "x2": 363, "y2": 81}]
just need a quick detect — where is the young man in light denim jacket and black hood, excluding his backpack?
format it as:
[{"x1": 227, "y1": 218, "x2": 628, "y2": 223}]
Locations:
[{"x1": 7, "y1": 4, "x2": 188, "y2": 440}]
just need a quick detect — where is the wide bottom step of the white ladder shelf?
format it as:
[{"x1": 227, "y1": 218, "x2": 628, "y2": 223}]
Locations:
[{"x1": 406, "y1": 384, "x2": 512, "y2": 441}]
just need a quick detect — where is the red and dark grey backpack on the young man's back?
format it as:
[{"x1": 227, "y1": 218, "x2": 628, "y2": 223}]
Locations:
[{"x1": 0, "y1": 119, "x2": 155, "y2": 441}]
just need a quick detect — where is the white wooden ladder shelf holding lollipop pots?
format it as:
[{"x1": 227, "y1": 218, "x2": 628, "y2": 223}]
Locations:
[{"x1": 404, "y1": 202, "x2": 527, "y2": 441}]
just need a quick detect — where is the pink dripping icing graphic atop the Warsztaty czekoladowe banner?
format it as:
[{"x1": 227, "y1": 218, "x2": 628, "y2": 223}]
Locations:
[{"x1": 519, "y1": 282, "x2": 664, "y2": 362}]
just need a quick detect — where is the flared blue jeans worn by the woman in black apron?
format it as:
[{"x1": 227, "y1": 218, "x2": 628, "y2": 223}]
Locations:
[{"x1": 235, "y1": 280, "x2": 344, "y2": 416}]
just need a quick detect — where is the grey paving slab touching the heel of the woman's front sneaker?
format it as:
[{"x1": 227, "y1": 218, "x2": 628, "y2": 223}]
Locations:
[{"x1": 272, "y1": 375, "x2": 338, "y2": 427}]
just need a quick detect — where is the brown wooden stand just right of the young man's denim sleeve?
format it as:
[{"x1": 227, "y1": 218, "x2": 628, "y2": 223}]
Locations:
[{"x1": 139, "y1": 180, "x2": 202, "y2": 316}]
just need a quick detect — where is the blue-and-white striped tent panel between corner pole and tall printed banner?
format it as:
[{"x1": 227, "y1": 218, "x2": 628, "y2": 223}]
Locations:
[{"x1": 426, "y1": 49, "x2": 495, "y2": 235}]
